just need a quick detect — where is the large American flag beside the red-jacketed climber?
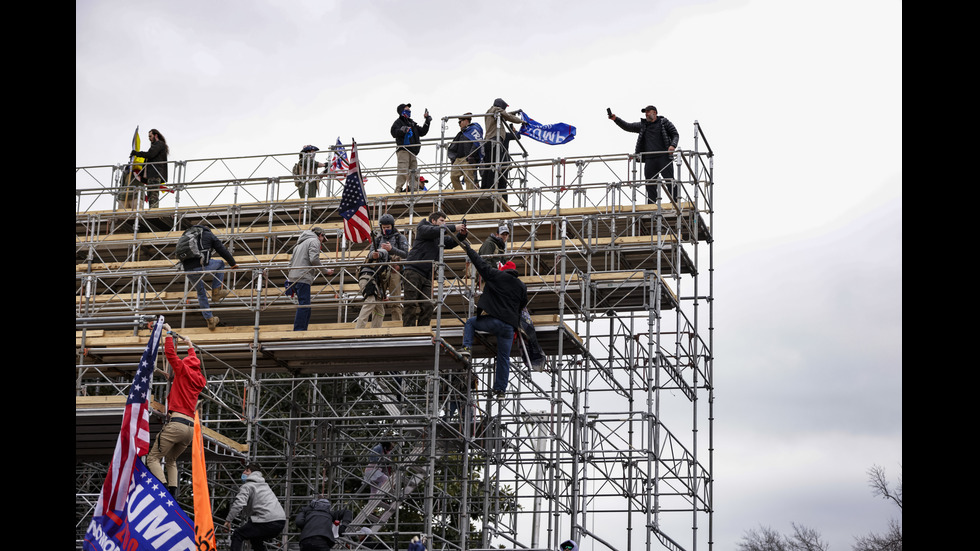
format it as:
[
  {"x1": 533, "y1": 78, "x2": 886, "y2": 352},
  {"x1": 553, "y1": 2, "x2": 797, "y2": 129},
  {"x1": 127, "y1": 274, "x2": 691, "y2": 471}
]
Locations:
[{"x1": 94, "y1": 316, "x2": 163, "y2": 517}]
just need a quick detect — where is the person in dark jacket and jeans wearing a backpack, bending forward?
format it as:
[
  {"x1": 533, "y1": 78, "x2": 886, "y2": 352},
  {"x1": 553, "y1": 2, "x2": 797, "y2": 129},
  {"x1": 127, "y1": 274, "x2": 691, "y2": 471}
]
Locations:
[{"x1": 177, "y1": 225, "x2": 238, "y2": 331}]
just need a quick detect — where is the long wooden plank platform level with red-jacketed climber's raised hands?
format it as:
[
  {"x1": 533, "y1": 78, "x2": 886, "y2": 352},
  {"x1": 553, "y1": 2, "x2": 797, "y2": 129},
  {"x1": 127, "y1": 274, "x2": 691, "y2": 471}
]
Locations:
[{"x1": 75, "y1": 315, "x2": 587, "y2": 379}]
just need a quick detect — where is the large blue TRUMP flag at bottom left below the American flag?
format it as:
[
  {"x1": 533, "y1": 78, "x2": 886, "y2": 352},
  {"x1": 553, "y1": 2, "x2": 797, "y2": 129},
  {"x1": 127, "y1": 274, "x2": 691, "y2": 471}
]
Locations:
[{"x1": 82, "y1": 460, "x2": 198, "y2": 551}]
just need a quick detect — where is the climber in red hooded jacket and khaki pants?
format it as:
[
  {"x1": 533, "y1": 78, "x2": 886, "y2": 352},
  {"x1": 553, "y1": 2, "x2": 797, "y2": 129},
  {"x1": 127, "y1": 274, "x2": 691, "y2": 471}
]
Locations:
[{"x1": 144, "y1": 323, "x2": 207, "y2": 495}]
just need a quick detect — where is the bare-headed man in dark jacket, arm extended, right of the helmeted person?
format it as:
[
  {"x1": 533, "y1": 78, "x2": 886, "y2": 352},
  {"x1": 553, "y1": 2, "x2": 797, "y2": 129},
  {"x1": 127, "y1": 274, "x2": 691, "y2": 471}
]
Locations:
[{"x1": 402, "y1": 211, "x2": 466, "y2": 327}]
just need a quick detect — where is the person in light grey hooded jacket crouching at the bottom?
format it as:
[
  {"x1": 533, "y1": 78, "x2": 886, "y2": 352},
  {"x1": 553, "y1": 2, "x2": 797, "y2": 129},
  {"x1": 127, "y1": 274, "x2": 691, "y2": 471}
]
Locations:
[{"x1": 225, "y1": 463, "x2": 286, "y2": 551}]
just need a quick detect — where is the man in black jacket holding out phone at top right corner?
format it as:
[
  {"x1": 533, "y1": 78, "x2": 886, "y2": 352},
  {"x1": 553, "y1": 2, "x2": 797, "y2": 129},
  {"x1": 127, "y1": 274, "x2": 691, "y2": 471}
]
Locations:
[{"x1": 609, "y1": 105, "x2": 680, "y2": 203}]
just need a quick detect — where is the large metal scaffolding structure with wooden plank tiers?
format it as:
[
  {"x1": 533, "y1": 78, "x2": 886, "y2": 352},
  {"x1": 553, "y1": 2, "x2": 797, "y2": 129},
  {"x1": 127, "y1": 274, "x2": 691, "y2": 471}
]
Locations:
[{"x1": 75, "y1": 116, "x2": 714, "y2": 551}]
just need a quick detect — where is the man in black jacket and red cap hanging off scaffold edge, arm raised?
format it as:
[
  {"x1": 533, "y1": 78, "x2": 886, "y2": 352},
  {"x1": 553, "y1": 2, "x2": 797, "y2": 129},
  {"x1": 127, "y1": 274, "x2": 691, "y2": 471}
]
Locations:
[{"x1": 460, "y1": 241, "x2": 527, "y2": 398}]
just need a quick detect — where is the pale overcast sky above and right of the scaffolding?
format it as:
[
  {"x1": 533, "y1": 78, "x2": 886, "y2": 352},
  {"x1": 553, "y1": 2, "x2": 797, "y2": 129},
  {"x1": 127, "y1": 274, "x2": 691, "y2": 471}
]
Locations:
[{"x1": 75, "y1": 0, "x2": 904, "y2": 551}]
